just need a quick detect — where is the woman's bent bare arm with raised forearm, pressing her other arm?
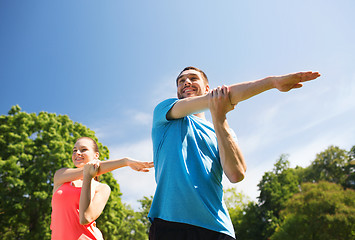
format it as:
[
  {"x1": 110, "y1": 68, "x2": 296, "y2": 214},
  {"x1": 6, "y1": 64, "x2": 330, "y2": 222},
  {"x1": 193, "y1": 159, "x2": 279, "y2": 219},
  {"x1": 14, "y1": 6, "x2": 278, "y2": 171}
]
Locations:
[{"x1": 79, "y1": 162, "x2": 111, "y2": 225}]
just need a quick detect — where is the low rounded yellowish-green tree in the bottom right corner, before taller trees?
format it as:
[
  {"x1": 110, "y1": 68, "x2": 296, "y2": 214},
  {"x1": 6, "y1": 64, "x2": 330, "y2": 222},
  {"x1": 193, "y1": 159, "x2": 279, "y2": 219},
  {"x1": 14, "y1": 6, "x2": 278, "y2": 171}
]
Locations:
[{"x1": 271, "y1": 181, "x2": 355, "y2": 240}]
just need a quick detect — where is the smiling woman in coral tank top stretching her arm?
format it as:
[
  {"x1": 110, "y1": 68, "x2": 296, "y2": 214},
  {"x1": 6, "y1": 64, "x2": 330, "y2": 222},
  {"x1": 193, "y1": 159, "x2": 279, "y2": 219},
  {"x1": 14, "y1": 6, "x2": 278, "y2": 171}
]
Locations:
[{"x1": 51, "y1": 137, "x2": 153, "y2": 240}]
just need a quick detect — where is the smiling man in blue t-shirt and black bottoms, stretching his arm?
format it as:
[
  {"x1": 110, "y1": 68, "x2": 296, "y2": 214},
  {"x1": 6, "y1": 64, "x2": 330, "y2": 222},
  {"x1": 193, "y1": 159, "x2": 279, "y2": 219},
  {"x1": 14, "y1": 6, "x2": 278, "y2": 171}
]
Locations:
[{"x1": 149, "y1": 67, "x2": 320, "y2": 240}]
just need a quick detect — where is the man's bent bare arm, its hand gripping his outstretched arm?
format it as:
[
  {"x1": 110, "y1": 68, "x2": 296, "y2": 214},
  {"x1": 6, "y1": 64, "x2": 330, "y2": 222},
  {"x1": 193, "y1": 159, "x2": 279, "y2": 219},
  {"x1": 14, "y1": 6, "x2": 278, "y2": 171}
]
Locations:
[{"x1": 209, "y1": 86, "x2": 247, "y2": 183}]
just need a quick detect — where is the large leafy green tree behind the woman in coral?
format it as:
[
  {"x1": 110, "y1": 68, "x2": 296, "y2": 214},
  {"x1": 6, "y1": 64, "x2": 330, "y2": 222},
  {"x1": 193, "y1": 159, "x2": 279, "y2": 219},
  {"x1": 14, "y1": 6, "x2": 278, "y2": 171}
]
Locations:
[{"x1": 0, "y1": 106, "x2": 145, "y2": 239}]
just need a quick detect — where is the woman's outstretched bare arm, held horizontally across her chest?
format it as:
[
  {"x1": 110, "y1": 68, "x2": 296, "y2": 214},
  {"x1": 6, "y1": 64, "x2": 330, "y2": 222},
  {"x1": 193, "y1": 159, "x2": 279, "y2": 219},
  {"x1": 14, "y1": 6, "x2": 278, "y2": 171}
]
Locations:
[{"x1": 53, "y1": 158, "x2": 154, "y2": 192}]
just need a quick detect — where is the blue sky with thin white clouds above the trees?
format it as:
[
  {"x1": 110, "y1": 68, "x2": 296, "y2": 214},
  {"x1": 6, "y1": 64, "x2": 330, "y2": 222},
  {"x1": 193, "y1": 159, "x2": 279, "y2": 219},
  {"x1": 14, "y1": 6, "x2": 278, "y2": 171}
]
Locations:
[{"x1": 0, "y1": 0, "x2": 355, "y2": 208}]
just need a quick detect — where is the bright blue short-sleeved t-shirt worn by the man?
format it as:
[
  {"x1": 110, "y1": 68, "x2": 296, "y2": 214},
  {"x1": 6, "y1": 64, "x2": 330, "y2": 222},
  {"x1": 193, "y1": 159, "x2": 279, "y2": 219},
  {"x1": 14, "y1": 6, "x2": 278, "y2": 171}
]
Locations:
[{"x1": 148, "y1": 98, "x2": 235, "y2": 237}]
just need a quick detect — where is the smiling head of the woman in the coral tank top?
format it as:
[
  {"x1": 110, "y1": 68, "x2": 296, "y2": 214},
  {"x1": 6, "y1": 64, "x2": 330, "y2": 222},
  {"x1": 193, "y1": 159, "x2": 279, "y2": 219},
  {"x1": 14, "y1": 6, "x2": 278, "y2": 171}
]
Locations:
[{"x1": 72, "y1": 138, "x2": 99, "y2": 168}]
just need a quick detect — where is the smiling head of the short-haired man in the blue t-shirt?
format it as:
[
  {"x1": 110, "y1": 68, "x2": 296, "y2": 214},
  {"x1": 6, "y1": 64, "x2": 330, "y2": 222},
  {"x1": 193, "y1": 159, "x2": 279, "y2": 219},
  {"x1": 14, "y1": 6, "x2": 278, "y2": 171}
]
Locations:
[{"x1": 177, "y1": 69, "x2": 210, "y2": 99}]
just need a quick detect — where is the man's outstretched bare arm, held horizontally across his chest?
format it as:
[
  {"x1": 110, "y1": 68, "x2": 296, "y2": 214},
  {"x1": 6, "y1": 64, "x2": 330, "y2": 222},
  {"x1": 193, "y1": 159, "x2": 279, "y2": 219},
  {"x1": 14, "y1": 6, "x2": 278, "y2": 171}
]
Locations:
[{"x1": 167, "y1": 72, "x2": 320, "y2": 119}]
